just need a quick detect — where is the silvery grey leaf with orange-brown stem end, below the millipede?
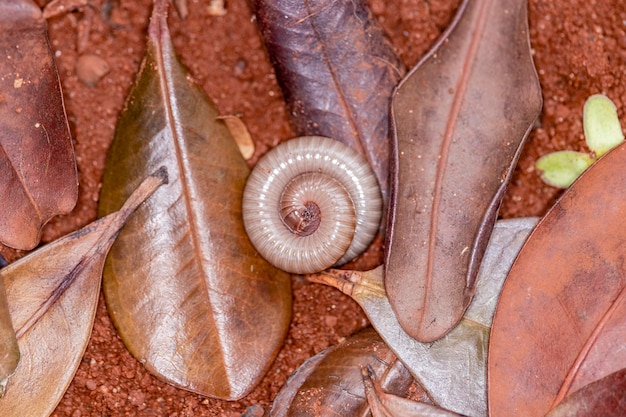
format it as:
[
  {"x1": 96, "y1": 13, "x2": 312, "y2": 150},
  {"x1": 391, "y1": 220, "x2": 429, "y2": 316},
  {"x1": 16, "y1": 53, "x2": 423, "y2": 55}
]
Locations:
[{"x1": 308, "y1": 218, "x2": 537, "y2": 417}]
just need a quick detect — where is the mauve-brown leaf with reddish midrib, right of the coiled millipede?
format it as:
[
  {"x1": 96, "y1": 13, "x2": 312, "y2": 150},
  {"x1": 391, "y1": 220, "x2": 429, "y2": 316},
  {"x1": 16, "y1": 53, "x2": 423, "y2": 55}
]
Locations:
[{"x1": 385, "y1": 0, "x2": 541, "y2": 342}]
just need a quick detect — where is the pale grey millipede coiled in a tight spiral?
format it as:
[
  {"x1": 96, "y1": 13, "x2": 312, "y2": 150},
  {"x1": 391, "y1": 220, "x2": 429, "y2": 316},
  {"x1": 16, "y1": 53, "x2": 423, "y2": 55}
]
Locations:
[{"x1": 243, "y1": 136, "x2": 382, "y2": 274}]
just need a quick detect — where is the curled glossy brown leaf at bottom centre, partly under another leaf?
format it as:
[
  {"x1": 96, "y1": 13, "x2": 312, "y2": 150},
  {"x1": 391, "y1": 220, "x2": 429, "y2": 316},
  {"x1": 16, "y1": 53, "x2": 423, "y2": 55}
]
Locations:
[{"x1": 270, "y1": 327, "x2": 420, "y2": 417}]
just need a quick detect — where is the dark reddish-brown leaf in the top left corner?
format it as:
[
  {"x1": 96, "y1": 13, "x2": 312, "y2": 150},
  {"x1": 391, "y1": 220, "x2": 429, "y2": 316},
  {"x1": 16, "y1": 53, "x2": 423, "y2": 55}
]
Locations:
[{"x1": 0, "y1": 0, "x2": 78, "y2": 249}]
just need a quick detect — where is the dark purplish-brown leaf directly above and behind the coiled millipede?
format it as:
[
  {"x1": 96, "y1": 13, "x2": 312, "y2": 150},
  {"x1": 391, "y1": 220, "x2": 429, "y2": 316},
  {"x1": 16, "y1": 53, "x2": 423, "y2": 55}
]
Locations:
[{"x1": 254, "y1": 0, "x2": 405, "y2": 247}]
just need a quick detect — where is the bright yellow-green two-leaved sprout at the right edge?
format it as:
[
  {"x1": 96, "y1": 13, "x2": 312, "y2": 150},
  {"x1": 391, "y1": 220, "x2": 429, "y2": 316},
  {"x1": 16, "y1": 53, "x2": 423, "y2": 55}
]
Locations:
[{"x1": 535, "y1": 94, "x2": 624, "y2": 188}]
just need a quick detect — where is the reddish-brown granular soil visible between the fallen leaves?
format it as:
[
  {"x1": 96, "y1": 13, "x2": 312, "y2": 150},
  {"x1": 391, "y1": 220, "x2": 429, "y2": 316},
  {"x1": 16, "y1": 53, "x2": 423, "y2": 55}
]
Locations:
[{"x1": 2, "y1": 0, "x2": 626, "y2": 417}]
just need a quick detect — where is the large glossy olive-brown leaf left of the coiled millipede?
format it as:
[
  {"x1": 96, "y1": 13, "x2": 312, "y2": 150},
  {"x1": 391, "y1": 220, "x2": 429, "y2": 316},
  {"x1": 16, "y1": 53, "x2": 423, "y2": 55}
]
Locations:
[{"x1": 99, "y1": 1, "x2": 291, "y2": 400}]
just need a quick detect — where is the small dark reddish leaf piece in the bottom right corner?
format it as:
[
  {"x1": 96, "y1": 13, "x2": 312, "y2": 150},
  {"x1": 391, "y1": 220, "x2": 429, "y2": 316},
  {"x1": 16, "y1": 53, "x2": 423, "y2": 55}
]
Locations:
[{"x1": 546, "y1": 369, "x2": 626, "y2": 417}]
